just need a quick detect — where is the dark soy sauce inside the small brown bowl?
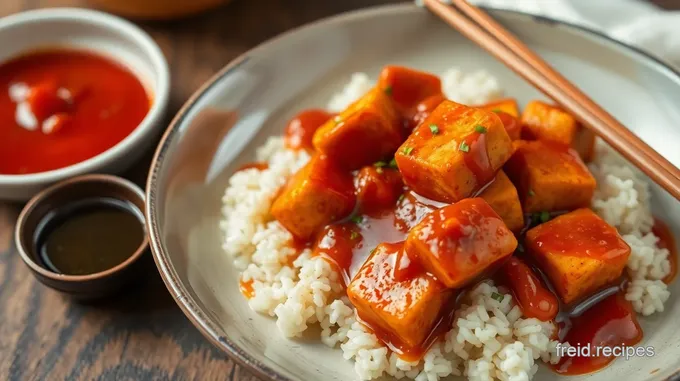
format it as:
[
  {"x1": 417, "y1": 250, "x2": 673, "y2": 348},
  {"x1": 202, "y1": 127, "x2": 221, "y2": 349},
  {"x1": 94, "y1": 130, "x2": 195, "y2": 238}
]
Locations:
[{"x1": 34, "y1": 197, "x2": 146, "y2": 275}]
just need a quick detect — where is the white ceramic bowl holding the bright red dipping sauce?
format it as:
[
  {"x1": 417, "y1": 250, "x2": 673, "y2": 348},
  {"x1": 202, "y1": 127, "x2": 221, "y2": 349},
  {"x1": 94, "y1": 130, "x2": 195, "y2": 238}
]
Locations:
[{"x1": 0, "y1": 8, "x2": 170, "y2": 200}]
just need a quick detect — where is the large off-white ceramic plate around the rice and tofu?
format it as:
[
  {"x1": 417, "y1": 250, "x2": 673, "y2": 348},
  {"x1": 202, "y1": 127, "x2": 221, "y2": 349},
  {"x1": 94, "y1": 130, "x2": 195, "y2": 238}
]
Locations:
[{"x1": 146, "y1": 5, "x2": 680, "y2": 381}]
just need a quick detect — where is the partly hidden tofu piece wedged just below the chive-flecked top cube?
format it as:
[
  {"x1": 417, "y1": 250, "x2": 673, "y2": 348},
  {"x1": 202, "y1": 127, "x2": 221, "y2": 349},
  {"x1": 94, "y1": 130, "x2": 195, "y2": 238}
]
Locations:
[{"x1": 479, "y1": 171, "x2": 524, "y2": 233}]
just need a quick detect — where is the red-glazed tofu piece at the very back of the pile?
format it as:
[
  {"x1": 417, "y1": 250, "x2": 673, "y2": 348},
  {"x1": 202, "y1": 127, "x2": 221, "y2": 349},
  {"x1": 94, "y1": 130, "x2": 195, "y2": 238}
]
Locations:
[{"x1": 378, "y1": 66, "x2": 442, "y2": 113}]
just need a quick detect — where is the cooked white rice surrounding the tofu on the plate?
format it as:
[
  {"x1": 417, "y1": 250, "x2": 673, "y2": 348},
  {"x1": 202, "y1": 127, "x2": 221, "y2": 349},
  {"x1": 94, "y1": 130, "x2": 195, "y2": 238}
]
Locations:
[{"x1": 221, "y1": 69, "x2": 670, "y2": 381}]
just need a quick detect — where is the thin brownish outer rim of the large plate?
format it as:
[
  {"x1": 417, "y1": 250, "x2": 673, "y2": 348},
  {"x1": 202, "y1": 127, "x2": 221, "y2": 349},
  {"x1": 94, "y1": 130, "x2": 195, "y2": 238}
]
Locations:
[{"x1": 145, "y1": 3, "x2": 680, "y2": 381}]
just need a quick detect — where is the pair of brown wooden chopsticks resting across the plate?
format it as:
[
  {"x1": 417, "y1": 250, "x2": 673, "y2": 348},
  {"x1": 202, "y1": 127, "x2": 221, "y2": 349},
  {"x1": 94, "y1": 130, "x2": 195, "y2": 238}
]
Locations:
[{"x1": 424, "y1": 0, "x2": 680, "y2": 200}]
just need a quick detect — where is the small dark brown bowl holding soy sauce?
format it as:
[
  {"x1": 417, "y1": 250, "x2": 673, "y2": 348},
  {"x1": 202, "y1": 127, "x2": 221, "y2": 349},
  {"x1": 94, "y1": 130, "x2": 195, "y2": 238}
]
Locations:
[{"x1": 15, "y1": 175, "x2": 149, "y2": 300}]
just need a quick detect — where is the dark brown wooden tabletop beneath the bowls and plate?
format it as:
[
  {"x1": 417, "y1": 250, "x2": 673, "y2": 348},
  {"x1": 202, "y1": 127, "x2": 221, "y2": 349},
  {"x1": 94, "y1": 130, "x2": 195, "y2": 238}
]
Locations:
[{"x1": 0, "y1": 0, "x2": 680, "y2": 381}]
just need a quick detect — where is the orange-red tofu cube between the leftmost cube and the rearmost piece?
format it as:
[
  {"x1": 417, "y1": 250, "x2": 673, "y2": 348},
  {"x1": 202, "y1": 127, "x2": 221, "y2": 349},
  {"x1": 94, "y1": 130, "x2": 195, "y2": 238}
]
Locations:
[{"x1": 312, "y1": 88, "x2": 403, "y2": 170}]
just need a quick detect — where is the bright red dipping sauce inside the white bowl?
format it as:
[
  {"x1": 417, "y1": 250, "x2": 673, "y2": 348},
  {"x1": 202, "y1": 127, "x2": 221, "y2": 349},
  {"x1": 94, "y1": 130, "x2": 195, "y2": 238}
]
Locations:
[{"x1": 0, "y1": 48, "x2": 151, "y2": 175}]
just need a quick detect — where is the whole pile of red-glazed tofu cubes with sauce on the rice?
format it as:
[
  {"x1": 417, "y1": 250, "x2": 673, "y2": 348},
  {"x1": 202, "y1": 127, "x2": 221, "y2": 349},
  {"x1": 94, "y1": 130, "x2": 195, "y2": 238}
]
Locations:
[{"x1": 255, "y1": 66, "x2": 674, "y2": 374}]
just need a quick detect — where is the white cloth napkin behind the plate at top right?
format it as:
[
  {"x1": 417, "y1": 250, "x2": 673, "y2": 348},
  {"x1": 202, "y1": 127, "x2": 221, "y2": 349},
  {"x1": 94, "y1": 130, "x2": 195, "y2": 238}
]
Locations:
[{"x1": 471, "y1": 0, "x2": 680, "y2": 68}]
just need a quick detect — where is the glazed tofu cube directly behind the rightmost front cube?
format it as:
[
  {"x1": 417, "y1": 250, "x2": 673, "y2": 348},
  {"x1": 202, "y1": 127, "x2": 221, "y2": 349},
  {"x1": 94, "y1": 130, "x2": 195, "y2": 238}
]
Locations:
[{"x1": 504, "y1": 140, "x2": 596, "y2": 213}]
